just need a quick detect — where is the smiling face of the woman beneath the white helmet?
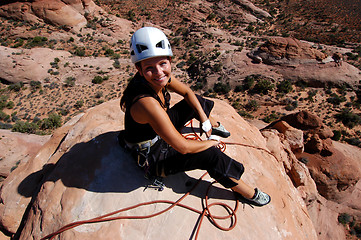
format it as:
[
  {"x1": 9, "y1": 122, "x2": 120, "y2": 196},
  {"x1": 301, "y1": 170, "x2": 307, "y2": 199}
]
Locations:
[{"x1": 136, "y1": 57, "x2": 172, "y2": 92}]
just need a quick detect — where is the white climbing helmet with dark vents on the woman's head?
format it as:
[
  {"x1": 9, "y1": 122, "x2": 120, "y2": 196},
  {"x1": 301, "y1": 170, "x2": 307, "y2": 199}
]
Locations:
[{"x1": 130, "y1": 27, "x2": 173, "y2": 63}]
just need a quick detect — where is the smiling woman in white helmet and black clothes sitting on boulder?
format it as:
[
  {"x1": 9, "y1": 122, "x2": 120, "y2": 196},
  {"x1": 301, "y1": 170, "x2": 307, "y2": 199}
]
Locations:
[{"x1": 120, "y1": 27, "x2": 270, "y2": 206}]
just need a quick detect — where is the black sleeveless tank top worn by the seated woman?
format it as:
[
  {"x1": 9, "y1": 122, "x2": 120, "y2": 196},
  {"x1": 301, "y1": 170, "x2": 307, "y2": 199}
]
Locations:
[{"x1": 124, "y1": 74, "x2": 170, "y2": 143}]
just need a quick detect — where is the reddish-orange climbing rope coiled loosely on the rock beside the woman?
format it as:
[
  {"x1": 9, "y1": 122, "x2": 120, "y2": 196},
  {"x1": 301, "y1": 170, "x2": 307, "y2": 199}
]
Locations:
[{"x1": 41, "y1": 120, "x2": 277, "y2": 240}]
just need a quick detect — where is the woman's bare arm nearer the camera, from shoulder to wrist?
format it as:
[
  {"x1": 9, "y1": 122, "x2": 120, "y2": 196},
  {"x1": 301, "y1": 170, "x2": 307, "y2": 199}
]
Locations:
[{"x1": 130, "y1": 97, "x2": 218, "y2": 154}]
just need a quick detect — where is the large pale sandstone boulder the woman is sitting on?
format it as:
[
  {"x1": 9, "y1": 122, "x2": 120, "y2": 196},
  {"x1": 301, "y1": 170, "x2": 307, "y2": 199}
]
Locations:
[{"x1": 0, "y1": 96, "x2": 317, "y2": 240}]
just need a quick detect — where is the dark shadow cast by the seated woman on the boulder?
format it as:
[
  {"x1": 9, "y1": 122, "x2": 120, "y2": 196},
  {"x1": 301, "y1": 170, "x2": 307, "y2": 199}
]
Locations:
[{"x1": 18, "y1": 132, "x2": 234, "y2": 199}]
